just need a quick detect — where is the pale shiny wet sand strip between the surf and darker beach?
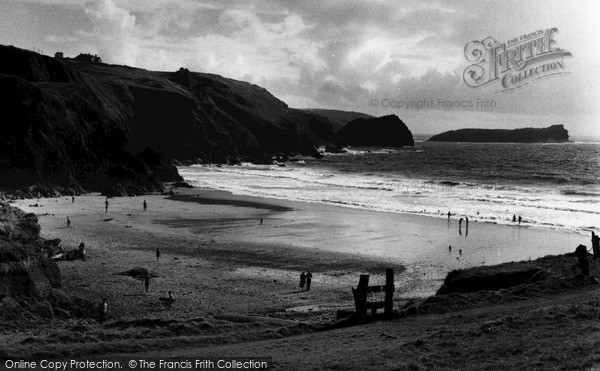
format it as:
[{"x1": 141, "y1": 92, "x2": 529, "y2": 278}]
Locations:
[{"x1": 168, "y1": 188, "x2": 588, "y2": 298}]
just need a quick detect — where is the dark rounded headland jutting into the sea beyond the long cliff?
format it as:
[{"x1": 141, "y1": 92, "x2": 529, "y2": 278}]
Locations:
[{"x1": 337, "y1": 115, "x2": 415, "y2": 147}]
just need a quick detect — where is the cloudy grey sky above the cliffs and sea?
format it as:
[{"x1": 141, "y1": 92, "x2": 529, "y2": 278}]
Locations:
[{"x1": 0, "y1": 0, "x2": 600, "y2": 136}]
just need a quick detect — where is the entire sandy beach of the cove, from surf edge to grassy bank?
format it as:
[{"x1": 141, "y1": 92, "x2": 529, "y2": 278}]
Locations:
[{"x1": 13, "y1": 185, "x2": 589, "y2": 321}]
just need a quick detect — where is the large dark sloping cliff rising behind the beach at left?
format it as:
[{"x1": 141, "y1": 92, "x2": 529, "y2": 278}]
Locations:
[{"x1": 0, "y1": 46, "x2": 337, "y2": 195}]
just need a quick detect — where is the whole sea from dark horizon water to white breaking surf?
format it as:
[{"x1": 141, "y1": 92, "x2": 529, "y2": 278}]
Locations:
[{"x1": 179, "y1": 136, "x2": 600, "y2": 235}]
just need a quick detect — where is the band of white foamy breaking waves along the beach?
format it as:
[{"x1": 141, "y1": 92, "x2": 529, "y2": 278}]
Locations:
[{"x1": 179, "y1": 157, "x2": 600, "y2": 234}]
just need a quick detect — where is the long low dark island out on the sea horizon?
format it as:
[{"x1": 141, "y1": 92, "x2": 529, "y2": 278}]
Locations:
[{"x1": 429, "y1": 125, "x2": 569, "y2": 143}]
